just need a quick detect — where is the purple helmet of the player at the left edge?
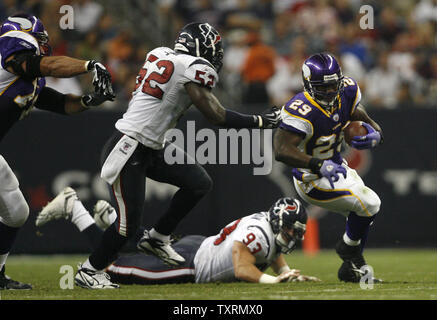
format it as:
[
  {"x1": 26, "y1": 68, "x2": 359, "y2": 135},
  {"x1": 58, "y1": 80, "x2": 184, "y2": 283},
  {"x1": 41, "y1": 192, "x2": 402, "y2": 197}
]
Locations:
[{"x1": 0, "y1": 13, "x2": 52, "y2": 55}]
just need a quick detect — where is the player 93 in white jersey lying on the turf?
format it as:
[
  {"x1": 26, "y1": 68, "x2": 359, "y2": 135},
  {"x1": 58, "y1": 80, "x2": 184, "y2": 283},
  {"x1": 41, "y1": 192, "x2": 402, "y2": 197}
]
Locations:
[{"x1": 37, "y1": 192, "x2": 319, "y2": 289}]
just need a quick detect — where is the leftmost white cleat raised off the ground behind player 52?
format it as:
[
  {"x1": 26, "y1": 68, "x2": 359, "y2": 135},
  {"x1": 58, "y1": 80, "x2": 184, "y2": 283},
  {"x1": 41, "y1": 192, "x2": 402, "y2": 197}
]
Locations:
[{"x1": 35, "y1": 187, "x2": 78, "y2": 227}]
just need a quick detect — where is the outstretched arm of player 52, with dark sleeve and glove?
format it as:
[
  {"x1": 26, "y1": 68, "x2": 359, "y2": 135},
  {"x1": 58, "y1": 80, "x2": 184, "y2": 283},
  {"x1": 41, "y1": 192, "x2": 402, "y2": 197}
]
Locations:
[{"x1": 185, "y1": 82, "x2": 280, "y2": 128}]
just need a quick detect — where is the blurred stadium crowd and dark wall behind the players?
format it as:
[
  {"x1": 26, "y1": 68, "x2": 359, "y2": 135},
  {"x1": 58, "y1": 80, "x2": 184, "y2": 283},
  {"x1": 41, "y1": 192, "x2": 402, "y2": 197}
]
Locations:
[{"x1": 0, "y1": 0, "x2": 437, "y2": 253}]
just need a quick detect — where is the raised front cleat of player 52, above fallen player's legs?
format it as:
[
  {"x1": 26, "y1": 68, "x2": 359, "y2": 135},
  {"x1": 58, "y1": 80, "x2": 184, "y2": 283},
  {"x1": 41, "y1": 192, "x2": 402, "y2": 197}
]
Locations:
[{"x1": 137, "y1": 230, "x2": 185, "y2": 266}]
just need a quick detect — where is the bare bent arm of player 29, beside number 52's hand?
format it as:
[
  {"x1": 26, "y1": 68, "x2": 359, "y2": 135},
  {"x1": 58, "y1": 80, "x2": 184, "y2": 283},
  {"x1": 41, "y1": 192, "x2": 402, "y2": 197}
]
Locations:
[{"x1": 273, "y1": 128, "x2": 311, "y2": 168}]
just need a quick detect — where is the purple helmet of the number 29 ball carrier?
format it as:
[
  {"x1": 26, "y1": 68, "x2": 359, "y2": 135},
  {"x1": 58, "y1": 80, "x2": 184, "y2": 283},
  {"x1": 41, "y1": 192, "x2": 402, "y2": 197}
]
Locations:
[{"x1": 302, "y1": 53, "x2": 344, "y2": 109}]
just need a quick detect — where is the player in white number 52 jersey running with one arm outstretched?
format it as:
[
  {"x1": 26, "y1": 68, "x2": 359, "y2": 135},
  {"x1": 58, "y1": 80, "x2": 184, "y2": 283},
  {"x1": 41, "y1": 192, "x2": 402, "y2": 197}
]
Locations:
[{"x1": 38, "y1": 23, "x2": 280, "y2": 287}]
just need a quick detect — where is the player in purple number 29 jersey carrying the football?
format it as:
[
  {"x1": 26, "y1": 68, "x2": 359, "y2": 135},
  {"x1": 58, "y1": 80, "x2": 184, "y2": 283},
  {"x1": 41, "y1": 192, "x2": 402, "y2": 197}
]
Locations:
[{"x1": 274, "y1": 53, "x2": 382, "y2": 282}]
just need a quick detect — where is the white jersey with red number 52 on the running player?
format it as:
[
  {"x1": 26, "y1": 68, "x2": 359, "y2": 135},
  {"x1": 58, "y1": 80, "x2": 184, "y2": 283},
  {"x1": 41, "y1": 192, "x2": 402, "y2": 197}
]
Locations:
[{"x1": 115, "y1": 47, "x2": 218, "y2": 150}]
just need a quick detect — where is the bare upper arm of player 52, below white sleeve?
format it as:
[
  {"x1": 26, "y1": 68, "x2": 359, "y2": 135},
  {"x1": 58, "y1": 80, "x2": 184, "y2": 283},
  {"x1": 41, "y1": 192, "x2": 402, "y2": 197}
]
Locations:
[{"x1": 185, "y1": 82, "x2": 226, "y2": 126}]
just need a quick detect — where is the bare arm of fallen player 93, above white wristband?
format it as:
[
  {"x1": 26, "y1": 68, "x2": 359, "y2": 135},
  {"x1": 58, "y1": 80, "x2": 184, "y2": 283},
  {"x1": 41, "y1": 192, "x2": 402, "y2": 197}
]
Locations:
[{"x1": 232, "y1": 241, "x2": 263, "y2": 282}]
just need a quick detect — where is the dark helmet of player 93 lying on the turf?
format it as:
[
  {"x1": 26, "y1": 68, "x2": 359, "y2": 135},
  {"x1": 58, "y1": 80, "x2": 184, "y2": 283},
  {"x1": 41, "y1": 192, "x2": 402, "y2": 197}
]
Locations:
[{"x1": 269, "y1": 198, "x2": 308, "y2": 254}]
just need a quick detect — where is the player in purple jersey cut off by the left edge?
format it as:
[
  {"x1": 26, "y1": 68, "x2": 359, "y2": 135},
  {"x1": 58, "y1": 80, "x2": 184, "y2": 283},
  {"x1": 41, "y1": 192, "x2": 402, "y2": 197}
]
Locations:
[{"x1": 0, "y1": 14, "x2": 114, "y2": 290}]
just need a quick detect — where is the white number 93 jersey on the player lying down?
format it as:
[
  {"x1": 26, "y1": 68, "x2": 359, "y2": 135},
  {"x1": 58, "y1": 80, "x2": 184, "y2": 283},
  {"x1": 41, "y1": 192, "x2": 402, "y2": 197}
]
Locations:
[{"x1": 194, "y1": 212, "x2": 280, "y2": 283}]
